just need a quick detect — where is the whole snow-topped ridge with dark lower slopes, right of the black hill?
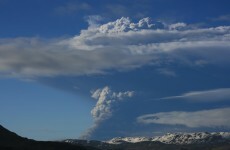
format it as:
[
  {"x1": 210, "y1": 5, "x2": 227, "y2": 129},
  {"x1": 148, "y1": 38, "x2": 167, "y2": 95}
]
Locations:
[{"x1": 63, "y1": 132, "x2": 230, "y2": 150}]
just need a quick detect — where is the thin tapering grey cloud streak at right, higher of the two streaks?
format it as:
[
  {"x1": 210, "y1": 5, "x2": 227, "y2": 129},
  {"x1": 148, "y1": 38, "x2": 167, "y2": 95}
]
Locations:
[{"x1": 161, "y1": 88, "x2": 230, "y2": 102}]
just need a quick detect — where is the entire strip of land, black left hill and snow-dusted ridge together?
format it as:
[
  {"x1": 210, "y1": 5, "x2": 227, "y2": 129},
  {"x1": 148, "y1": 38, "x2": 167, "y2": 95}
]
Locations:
[{"x1": 0, "y1": 125, "x2": 230, "y2": 150}]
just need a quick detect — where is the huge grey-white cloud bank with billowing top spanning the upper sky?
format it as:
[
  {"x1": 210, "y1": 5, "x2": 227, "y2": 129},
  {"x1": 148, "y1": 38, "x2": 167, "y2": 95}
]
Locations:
[{"x1": 0, "y1": 18, "x2": 230, "y2": 77}]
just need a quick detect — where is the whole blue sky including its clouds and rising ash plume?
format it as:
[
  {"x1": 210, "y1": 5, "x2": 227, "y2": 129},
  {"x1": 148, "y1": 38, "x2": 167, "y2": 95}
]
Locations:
[{"x1": 0, "y1": 0, "x2": 230, "y2": 140}]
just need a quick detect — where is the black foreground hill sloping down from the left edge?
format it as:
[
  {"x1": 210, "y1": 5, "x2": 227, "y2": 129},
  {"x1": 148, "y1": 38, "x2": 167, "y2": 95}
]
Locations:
[{"x1": 0, "y1": 125, "x2": 96, "y2": 150}]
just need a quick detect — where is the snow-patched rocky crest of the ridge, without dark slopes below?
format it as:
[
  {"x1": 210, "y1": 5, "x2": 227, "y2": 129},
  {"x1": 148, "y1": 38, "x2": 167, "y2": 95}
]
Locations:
[{"x1": 106, "y1": 132, "x2": 230, "y2": 145}]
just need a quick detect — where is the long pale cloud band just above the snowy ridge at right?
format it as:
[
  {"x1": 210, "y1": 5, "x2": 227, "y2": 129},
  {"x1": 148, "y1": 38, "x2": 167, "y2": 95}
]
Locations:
[{"x1": 137, "y1": 107, "x2": 230, "y2": 128}]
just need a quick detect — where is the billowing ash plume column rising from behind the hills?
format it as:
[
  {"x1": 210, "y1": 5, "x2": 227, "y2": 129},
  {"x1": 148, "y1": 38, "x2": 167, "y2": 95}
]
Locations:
[{"x1": 81, "y1": 86, "x2": 134, "y2": 139}]
